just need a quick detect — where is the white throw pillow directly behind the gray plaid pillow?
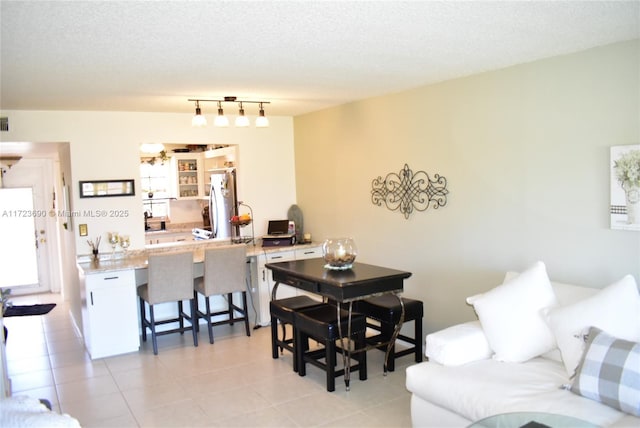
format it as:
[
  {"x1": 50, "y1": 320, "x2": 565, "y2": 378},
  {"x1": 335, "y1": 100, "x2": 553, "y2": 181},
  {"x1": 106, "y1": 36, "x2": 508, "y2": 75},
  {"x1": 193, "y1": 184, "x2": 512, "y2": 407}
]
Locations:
[{"x1": 547, "y1": 275, "x2": 640, "y2": 376}]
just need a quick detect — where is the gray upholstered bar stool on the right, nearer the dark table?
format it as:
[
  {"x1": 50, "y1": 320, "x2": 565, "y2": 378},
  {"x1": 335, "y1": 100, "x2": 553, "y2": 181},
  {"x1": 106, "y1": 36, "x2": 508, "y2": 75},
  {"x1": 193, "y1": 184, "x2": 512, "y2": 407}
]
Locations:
[{"x1": 192, "y1": 245, "x2": 251, "y2": 343}]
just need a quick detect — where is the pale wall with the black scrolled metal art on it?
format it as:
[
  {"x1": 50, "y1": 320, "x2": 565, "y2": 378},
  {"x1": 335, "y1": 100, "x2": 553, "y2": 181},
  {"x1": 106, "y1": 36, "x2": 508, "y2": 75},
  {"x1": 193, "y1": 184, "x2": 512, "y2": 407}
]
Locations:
[{"x1": 294, "y1": 41, "x2": 640, "y2": 332}]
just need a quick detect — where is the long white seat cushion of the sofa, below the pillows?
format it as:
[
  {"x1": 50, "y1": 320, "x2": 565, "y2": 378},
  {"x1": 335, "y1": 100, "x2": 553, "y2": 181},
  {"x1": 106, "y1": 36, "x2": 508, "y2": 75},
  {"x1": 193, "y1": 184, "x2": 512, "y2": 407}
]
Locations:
[{"x1": 406, "y1": 357, "x2": 638, "y2": 426}]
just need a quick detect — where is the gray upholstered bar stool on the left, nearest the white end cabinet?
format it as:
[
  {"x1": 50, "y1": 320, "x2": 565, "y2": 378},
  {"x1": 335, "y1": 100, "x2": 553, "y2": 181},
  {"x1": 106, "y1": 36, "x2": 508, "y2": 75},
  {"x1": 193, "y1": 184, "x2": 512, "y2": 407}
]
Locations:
[{"x1": 137, "y1": 252, "x2": 198, "y2": 355}]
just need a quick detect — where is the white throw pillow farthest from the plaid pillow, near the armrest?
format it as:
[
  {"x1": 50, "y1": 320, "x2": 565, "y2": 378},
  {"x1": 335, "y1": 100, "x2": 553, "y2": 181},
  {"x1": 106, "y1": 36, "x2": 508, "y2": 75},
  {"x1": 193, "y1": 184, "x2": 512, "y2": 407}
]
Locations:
[{"x1": 467, "y1": 262, "x2": 556, "y2": 362}]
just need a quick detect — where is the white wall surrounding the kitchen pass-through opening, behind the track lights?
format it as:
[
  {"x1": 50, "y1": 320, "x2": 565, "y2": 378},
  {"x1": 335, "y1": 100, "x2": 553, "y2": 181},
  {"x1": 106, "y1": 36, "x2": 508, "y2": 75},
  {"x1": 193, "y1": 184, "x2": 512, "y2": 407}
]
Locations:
[{"x1": 0, "y1": 111, "x2": 295, "y2": 254}]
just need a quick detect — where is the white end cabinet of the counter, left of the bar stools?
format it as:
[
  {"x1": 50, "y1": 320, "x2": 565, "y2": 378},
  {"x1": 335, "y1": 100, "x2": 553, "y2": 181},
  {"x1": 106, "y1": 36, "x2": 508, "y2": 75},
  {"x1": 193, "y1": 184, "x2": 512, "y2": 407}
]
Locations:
[{"x1": 80, "y1": 269, "x2": 140, "y2": 359}]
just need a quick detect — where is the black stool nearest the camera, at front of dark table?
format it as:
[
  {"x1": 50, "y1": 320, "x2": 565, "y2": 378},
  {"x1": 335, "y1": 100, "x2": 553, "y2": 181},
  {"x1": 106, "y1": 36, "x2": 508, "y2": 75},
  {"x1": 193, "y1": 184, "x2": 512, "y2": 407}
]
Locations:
[{"x1": 293, "y1": 304, "x2": 367, "y2": 392}]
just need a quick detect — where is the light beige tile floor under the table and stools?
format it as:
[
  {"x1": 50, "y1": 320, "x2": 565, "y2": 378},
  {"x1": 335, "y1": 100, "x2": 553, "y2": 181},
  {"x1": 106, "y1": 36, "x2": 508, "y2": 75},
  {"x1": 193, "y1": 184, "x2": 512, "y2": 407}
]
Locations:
[{"x1": 4, "y1": 294, "x2": 414, "y2": 427}]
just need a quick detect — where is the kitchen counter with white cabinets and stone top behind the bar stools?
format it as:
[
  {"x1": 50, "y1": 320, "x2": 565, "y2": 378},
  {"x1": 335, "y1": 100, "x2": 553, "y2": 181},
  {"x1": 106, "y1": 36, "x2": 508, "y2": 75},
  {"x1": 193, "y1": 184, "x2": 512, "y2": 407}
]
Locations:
[{"x1": 77, "y1": 239, "x2": 322, "y2": 359}]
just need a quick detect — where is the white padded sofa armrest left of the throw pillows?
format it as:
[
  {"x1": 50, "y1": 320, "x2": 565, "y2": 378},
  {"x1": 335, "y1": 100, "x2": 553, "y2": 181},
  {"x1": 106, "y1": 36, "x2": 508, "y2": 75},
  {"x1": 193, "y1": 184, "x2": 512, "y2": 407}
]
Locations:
[{"x1": 425, "y1": 321, "x2": 493, "y2": 366}]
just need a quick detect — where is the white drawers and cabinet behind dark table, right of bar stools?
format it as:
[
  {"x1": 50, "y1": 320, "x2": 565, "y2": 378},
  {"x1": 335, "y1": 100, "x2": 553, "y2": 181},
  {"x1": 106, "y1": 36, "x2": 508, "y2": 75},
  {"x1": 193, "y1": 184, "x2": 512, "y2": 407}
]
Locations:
[{"x1": 251, "y1": 246, "x2": 322, "y2": 325}]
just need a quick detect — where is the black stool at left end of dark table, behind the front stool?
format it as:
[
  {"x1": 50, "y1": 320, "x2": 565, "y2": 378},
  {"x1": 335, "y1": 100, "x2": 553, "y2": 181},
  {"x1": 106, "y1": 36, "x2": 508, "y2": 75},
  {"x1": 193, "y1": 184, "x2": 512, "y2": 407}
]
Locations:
[{"x1": 269, "y1": 296, "x2": 322, "y2": 372}]
